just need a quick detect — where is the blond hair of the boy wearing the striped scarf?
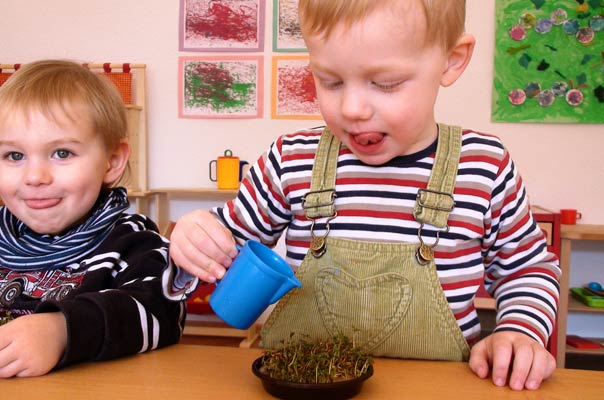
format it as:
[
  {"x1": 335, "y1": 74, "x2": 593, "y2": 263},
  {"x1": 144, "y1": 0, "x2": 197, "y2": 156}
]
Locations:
[{"x1": 0, "y1": 60, "x2": 129, "y2": 184}]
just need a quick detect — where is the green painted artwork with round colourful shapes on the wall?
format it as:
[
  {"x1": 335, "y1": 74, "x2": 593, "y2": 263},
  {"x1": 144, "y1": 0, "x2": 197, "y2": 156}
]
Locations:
[{"x1": 492, "y1": 0, "x2": 604, "y2": 123}]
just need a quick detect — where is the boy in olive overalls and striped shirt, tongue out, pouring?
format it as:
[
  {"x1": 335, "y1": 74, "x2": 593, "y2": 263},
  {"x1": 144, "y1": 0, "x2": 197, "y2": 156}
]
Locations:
[{"x1": 170, "y1": 0, "x2": 560, "y2": 390}]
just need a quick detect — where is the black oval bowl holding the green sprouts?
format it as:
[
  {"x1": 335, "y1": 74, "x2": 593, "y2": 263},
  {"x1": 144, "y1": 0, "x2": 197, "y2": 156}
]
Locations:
[{"x1": 252, "y1": 357, "x2": 373, "y2": 400}]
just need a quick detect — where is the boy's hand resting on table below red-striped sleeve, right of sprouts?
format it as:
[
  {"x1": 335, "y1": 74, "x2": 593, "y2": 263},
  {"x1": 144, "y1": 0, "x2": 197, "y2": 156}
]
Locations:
[{"x1": 469, "y1": 331, "x2": 556, "y2": 390}]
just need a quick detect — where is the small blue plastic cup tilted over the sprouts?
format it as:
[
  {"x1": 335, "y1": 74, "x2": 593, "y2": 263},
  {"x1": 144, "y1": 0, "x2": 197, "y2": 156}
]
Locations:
[{"x1": 210, "y1": 240, "x2": 302, "y2": 329}]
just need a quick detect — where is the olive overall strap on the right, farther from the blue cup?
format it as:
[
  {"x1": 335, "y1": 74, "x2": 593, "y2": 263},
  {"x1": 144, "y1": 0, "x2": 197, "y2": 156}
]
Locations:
[{"x1": 413, "y1": 124, "x2": 461, "y2": 228}]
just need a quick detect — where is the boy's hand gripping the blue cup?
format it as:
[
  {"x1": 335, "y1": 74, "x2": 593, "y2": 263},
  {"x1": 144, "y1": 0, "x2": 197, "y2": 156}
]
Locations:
[{"x1": 170, "y1": 210, "x2": 237, "y2": 282}]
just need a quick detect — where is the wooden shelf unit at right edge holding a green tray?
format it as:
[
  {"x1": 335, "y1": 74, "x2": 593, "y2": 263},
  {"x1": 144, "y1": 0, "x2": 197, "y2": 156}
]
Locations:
[{"x1": 557, "y1": 224, "x2": 604, "y2": 368}]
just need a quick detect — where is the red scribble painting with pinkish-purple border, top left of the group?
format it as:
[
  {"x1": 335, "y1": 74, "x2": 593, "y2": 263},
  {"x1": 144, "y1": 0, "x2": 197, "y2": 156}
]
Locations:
[{"x1": 180, "y1": 0, "x2": 264, "y2": 51}]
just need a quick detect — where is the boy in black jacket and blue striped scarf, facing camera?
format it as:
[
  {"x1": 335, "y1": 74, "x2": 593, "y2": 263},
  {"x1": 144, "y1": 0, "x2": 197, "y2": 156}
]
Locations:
[{"x1": 0, "y1": 60, "x2": 186, "y2": 376}]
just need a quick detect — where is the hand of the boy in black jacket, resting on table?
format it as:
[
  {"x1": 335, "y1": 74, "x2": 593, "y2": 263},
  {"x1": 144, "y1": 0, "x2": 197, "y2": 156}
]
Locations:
[{"x1": 0, "y1": 312, "x2": 67, "y2": 378}]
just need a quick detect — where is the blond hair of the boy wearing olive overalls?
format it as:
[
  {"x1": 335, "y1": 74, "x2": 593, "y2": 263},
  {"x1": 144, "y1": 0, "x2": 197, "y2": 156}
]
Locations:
[{"x1": 298, "y1": 0, "x2": 466, "y2": 50}]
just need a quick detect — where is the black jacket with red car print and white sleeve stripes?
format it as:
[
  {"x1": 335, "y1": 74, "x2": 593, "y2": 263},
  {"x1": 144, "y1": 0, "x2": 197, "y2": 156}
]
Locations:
[{"x1": 0, "y1": 213, "x2": 186, "y2": 367}]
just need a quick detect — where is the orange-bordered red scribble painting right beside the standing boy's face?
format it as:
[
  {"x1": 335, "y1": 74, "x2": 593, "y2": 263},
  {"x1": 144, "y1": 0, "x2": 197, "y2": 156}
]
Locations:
[{"x1": 271, "y1": 56, "x2": 321, "y2": 119}]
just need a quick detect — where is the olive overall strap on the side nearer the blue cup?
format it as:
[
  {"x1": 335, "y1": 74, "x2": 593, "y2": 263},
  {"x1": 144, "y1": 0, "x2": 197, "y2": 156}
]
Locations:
[{"x1": 302, "y1": 128, "x2": 340, "y2": 220}]
